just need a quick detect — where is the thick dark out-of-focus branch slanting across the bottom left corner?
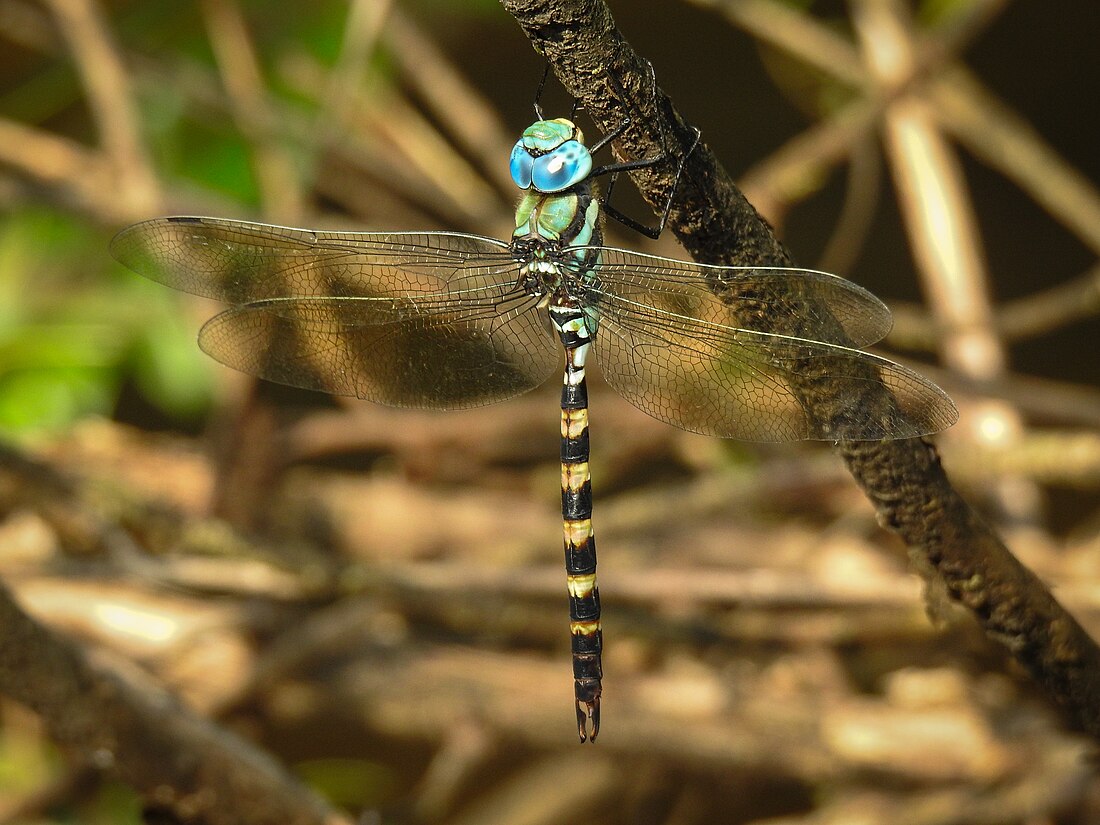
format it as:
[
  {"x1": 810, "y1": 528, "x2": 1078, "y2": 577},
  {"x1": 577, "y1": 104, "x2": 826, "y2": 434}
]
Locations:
[{"x1": 0, "y1": 586, "x2": 347, "y2": 825}]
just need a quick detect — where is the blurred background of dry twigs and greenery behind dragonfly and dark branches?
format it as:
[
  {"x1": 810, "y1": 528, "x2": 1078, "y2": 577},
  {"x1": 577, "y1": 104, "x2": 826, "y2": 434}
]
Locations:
[{"x1": 0, "y1": 0, "x2": 1100, "y2": 825}]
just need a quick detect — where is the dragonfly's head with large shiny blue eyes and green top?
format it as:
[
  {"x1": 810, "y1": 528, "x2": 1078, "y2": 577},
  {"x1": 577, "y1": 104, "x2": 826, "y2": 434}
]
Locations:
[{"x1": 508, "y1": 118, "x2": 592, "y2": 193}]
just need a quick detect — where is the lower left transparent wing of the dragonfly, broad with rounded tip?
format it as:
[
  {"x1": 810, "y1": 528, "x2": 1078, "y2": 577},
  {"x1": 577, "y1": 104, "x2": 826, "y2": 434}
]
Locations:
[{"x1": 199, "y1": 292, "x2": 561, "y2": 409}]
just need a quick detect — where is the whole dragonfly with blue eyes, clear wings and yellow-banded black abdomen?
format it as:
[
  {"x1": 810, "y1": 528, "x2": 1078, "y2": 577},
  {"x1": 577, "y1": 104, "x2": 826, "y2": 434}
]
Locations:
[{"x1": 111, "y1": 114, "x2": 958, "y2": 743}]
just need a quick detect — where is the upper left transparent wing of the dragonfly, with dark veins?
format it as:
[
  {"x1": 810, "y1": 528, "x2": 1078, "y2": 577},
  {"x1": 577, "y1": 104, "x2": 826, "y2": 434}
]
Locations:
[{"x1": 111, "y1": 218, "x2": 517, "y2": 304}]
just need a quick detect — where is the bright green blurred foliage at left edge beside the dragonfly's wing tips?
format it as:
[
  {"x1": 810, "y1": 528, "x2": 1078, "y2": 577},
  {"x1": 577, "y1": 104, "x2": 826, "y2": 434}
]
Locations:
[{"x1": 0, "y1": 210, "x2": 212, "y2": 435}]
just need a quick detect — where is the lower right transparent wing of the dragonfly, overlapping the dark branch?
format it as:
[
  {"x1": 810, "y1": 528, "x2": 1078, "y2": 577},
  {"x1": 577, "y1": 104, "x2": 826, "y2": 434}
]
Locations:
[{"x1": 595, "y1": 292, "x2": 958, "y2": 441}]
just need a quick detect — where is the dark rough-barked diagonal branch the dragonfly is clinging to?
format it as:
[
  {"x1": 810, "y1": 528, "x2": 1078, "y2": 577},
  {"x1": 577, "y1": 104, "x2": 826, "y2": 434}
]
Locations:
[{"x1": 502, "y1": 0, "x2": 1100, "y2": 737}]
